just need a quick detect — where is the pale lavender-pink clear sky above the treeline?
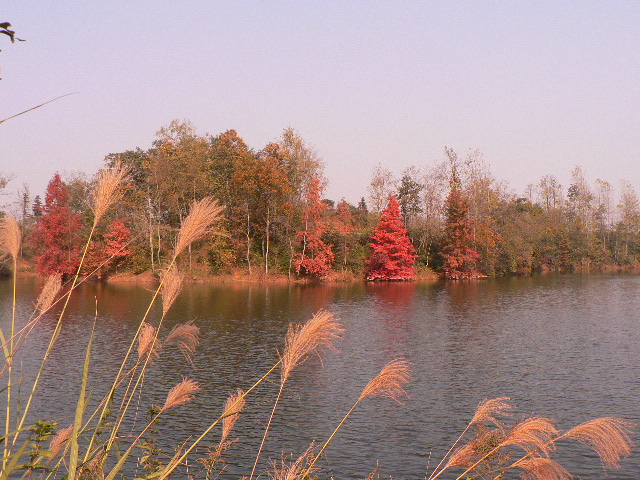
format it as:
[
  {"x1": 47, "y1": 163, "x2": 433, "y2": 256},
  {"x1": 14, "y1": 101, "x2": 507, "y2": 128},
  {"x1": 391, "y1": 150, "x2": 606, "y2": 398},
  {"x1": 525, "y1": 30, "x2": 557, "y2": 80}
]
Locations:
[{"x1": 0, "y1": 0, "x2": 640, "y2": 203}]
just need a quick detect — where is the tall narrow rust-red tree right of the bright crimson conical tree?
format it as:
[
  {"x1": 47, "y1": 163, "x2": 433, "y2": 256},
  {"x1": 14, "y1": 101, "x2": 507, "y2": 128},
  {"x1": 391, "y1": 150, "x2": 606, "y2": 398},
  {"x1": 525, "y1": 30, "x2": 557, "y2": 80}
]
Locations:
[{"x1": 442, "y1": 166, "x2": 481, "y2": 280}]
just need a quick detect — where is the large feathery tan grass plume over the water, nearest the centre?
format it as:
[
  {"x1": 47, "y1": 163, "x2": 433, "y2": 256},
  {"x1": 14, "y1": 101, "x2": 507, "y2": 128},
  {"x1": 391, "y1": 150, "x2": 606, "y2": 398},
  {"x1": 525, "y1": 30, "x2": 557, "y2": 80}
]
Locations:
[{"x1": 281, "y1": 310, "x2": 344, "y2": 385}]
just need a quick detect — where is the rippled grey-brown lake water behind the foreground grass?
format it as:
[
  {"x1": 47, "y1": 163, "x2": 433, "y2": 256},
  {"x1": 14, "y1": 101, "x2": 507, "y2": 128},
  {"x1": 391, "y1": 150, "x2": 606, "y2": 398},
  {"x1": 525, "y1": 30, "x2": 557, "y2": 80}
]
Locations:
[{"x1": 0, "y1": 275, "x2": 640, "y2": 479}]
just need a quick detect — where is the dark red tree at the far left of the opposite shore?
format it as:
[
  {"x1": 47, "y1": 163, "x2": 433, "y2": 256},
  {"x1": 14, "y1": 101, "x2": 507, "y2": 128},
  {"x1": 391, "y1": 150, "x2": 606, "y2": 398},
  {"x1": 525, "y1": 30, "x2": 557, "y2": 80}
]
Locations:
[{"x1": 31, "y1": 173, "x2": 82, "y2": 275}]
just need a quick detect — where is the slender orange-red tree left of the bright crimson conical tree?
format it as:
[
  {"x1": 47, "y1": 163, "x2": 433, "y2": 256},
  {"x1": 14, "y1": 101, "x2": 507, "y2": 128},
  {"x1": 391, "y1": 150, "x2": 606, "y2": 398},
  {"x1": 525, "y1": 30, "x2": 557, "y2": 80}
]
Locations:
[{"x1": 296, "y1": 178, "x2": 335, "y2": 278}]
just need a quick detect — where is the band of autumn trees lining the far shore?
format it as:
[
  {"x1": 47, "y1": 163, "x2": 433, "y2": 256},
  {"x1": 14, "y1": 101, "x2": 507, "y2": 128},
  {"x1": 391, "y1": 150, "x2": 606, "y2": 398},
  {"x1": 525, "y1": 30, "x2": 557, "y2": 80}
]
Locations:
[{"x1": 4, "y1": 121, "x2": 640, "y2": 280}]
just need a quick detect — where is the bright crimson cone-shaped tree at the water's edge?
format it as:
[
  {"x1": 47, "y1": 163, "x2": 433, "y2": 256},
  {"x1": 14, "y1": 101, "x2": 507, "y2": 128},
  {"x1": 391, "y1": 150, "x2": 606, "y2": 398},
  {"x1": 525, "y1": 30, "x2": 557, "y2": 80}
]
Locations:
[{"x1": 365, "y1": 195, "x2": 416, "y2": 280}]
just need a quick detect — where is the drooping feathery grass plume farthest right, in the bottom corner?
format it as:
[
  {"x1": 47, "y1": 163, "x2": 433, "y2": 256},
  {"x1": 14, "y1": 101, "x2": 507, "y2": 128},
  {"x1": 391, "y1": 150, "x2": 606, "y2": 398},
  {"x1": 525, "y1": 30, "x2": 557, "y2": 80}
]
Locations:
[{"x1": 563, "y1": 417, "x2": 635, "y2": 468}]
